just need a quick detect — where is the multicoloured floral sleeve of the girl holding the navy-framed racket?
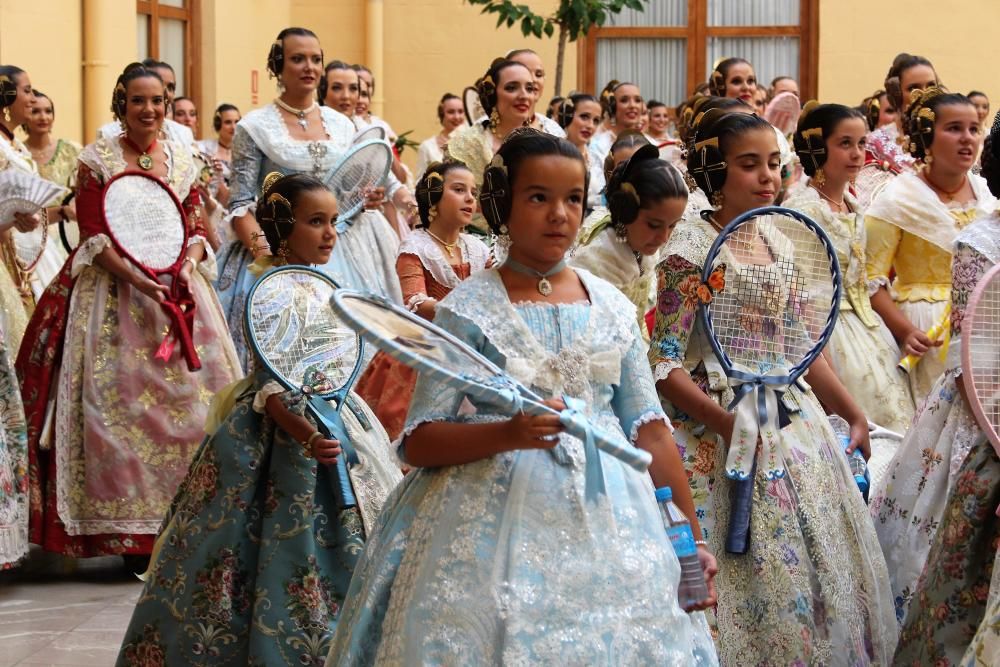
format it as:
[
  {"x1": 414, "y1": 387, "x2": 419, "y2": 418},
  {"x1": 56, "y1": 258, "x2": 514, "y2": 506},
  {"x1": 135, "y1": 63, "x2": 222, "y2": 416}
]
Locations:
[{"x1": 649, "y1": 255, "x2": 701, "y2": 381}]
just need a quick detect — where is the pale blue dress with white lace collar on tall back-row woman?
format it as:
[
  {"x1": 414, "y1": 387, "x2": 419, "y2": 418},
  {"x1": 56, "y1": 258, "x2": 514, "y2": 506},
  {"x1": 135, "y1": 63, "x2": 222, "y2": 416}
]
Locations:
[{"x1": 216, "y1": 104, "x2": 401, "y2": 368}]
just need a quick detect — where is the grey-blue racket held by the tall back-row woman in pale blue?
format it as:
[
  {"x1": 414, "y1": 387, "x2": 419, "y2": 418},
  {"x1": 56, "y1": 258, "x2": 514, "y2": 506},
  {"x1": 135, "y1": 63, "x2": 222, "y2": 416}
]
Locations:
[{"x1": 323, "y1": 139, "x2": 392, "y2": 232}]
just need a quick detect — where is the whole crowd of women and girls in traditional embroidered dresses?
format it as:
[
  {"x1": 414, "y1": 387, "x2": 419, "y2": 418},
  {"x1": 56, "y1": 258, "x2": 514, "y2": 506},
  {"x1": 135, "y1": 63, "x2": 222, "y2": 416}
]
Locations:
[{"x1": 0, "y1": 28, "x2": 1000, "y2": 665}]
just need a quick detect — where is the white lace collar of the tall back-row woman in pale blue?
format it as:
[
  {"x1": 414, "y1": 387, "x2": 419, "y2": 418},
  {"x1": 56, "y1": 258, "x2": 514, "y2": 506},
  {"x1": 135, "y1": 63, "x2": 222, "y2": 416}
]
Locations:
[{"x1": 236, "y1": 104, "x2": 355, "y2": 176}]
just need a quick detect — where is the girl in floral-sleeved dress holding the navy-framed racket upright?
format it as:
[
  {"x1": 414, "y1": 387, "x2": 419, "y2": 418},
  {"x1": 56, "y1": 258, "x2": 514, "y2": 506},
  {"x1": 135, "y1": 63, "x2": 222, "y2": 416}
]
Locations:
[{"x1": 649, "y1": 109, "x2": 896, "y2": 665}]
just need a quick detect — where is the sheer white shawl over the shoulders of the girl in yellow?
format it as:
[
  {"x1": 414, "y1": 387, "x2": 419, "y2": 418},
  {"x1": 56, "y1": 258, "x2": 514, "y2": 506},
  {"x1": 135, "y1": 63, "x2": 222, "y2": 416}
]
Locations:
[{"x1": 866, "y1": 173, "x2": 997, "y2": 254}]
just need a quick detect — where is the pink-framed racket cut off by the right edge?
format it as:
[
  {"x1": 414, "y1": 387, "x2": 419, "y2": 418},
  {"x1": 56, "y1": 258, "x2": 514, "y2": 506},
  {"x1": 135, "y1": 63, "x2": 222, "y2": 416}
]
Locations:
[{"x1": 962, "y1": 264, "x2": 1000, "y2": 453}]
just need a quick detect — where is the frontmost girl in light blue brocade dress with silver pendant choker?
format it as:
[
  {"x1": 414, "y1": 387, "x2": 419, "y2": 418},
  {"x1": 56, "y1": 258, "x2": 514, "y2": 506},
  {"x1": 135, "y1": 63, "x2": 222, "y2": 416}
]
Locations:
[{"x1": 327, "y1": 129, "x2": 716, "y2": 665}]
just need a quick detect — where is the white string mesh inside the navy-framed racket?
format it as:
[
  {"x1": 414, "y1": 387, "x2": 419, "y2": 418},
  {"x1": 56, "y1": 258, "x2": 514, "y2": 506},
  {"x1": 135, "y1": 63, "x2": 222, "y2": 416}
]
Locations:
[{"x1": 708, "y1": 215, "x2": 839, "y2": 373}]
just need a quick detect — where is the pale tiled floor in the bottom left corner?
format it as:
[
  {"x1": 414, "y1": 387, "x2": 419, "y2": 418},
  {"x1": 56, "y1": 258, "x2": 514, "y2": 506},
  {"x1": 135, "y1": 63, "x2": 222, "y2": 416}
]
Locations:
[{"x1": 0, "y1": 556, "x2": 142, "y2": 667}]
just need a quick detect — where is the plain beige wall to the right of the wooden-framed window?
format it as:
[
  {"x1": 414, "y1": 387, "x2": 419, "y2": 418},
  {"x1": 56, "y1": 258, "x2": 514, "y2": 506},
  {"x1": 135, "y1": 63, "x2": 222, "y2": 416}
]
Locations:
[{"x1": 819, "y1": 0, "x2": 1000, "y2": 109}]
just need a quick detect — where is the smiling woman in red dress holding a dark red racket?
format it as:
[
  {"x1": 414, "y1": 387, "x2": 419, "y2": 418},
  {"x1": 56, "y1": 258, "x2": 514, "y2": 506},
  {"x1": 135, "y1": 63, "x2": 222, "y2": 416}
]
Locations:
[{"x1": 17, "y1": 63, "x2": 242, "y2": 567}]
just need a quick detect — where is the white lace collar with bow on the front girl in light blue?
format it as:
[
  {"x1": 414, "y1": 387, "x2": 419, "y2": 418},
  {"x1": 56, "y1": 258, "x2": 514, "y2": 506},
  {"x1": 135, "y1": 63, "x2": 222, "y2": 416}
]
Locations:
[{"x1": 438, "y1": 269, "x2": 634, "y2": 405}]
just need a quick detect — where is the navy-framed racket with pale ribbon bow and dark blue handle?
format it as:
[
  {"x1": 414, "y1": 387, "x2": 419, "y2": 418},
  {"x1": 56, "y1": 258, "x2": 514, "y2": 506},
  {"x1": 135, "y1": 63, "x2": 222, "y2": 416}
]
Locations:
[{"x1": 698, "y1": 206, "x2": 841, "y2": 554}]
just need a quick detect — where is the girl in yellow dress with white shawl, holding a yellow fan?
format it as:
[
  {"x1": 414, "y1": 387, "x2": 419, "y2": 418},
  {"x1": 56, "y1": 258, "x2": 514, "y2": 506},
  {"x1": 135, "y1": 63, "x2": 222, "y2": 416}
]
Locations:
[{"x1": 865, "y1": 87, "x2": 997, "y2": 405}]
